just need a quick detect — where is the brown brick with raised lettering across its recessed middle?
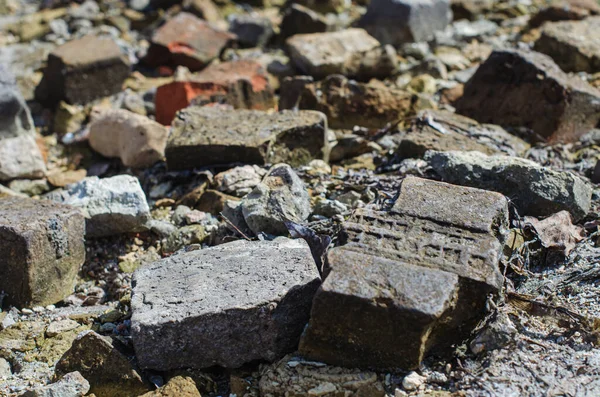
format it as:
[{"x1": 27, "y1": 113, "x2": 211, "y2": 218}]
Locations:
[{"x1": 300, "y1": 177, "x2": 508, "y2": 369}]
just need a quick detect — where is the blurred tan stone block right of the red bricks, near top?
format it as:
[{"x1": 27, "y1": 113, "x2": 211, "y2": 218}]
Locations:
[{"x1": 286, "y1": 29, "x2": 398, "y2": 80}]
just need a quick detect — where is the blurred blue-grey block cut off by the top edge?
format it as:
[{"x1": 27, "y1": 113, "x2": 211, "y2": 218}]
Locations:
[{"x1": 359, "y1": 0, "x2": 452, "y2": 46}]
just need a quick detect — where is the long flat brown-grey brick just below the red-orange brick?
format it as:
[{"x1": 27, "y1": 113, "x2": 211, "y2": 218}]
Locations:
[{"x1": 166, "y1": 107, "x2": 330, "y2": 170}]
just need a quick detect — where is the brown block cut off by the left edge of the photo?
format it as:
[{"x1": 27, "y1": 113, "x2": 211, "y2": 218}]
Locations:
[{"x1": 0, "y1": 198, "x2": 85, "y2": 307}]
